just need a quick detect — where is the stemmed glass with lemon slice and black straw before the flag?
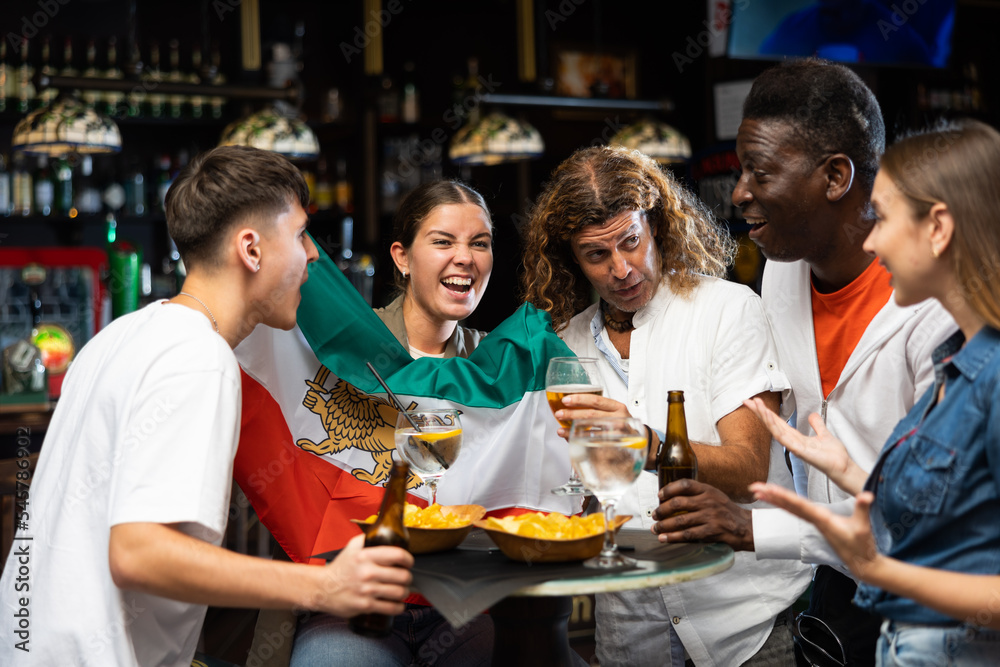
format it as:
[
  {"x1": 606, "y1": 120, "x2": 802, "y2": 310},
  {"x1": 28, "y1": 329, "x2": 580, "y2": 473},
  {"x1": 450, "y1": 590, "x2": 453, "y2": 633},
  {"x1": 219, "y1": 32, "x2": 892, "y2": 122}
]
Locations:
[{"x1": 395, "y1": 410, "x2": 462, "y2": 505}]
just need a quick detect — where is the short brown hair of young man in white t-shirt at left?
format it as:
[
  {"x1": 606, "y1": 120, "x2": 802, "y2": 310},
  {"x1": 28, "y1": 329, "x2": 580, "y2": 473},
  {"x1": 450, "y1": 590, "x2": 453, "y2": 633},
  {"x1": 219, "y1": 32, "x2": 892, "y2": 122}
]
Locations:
[{"x1": 164, "y1": 146, "x2": 309, "y2": 268}]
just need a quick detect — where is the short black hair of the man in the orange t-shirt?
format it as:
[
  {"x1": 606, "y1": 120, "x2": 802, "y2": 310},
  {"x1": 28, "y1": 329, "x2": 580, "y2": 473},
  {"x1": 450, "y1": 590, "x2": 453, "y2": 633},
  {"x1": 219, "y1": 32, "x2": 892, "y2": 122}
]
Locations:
[{"x1": 743, "y1": 58, "x2": 885, "y2": 191}]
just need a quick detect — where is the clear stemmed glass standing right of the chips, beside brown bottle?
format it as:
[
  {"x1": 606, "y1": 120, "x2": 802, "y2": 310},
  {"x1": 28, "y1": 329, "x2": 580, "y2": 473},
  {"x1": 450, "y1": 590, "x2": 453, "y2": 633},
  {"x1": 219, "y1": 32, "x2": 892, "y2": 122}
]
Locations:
[{"x1": 569, "y1": 417, "x2": 649, "y2": 568}]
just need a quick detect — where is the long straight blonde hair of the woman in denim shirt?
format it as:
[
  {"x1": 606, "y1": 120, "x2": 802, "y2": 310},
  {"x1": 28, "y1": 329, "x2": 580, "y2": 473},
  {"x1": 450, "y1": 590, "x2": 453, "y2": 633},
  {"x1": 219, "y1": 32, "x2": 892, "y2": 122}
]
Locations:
[{"x1": 881, "y1": 120, "x2": 1000, "y2": 329}]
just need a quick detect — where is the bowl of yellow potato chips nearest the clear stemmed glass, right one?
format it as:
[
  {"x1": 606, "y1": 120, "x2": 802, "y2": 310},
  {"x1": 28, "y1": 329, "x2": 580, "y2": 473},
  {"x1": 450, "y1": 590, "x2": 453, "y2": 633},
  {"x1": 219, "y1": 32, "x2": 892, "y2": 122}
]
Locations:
[{"x1": 473, "y1": 512, "x2": 632, "y2": 563}]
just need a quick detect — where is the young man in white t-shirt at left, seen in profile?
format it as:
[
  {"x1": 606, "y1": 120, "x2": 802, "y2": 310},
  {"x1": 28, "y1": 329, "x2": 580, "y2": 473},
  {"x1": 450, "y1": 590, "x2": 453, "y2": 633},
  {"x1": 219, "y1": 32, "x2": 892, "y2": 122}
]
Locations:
[{"x1": 0, "y1": 147, "x2": 413, "y2": 666}]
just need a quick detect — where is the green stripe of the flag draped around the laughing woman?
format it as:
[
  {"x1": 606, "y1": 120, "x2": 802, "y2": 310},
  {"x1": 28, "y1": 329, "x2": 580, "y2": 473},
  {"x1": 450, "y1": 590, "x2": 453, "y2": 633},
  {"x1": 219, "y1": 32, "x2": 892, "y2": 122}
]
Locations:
[{"x1": 298, "y1": 237, "x2": 573, "y2": 408}]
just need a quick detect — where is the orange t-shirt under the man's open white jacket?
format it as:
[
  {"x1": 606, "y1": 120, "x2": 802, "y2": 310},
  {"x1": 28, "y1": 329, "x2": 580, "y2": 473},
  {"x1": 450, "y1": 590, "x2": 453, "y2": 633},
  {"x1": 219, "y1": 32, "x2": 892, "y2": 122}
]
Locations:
[{"x1": 812, "y1": 260, "x2": 892, "y2": 397}]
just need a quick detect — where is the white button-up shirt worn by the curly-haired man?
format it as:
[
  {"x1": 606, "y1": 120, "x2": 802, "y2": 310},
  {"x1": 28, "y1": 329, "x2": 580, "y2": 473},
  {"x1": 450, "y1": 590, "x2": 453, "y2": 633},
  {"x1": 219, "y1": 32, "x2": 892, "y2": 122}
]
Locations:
[{"x1": 562, "y1": 277, "x2": 810, "y2": 667}]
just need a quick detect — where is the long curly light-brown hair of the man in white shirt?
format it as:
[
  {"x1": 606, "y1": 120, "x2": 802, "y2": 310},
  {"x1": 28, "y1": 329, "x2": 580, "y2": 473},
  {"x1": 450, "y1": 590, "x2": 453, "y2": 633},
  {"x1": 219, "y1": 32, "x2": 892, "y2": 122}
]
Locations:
[{"x1": 521, "y1": 146, "x2": 736, "y2": 331}]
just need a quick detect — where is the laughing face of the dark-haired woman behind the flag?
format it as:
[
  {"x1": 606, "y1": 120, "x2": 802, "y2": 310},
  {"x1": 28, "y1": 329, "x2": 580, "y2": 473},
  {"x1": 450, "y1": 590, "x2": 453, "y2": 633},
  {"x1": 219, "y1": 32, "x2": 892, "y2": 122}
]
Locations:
[{"x1": 393, "y1": 204, "x2": 493, "y2": 323}]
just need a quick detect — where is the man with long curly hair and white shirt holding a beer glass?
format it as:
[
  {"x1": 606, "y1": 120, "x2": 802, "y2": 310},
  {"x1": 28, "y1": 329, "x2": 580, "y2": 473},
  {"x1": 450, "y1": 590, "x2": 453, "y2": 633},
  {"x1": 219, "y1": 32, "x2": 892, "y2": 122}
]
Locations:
[{"x1": 523, "y1": 147, "x2": 809, "y2": 667}]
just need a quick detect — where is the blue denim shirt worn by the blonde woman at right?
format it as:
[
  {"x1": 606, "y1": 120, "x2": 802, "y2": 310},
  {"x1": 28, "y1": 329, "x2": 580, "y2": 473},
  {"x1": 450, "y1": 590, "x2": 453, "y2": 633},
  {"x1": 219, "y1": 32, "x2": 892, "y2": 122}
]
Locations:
[{"x1": 854, "y1": 326, "x2": 1000, "y2": 624}]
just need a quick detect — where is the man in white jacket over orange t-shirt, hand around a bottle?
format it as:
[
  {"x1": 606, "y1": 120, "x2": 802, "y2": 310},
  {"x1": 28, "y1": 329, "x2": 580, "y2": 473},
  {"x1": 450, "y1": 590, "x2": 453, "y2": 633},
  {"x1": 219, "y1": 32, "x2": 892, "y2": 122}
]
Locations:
[{"x1": 654, "y1": 60, "x2": 955, "y2": 665}]
